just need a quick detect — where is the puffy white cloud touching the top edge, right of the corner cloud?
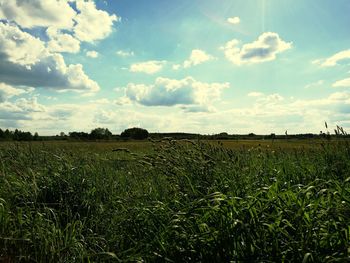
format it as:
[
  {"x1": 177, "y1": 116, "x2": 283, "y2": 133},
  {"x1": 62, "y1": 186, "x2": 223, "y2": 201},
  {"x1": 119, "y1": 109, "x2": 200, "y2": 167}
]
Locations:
[{"x1": 74, "y1": 0, "x2": 117, "y2": 42}]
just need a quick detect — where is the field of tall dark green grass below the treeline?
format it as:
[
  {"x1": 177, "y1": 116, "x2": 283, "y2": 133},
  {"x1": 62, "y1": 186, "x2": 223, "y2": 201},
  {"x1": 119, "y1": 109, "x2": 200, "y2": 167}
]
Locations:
[{"x1": 0, "y1": 139, "x2": 350, "y2": 263}]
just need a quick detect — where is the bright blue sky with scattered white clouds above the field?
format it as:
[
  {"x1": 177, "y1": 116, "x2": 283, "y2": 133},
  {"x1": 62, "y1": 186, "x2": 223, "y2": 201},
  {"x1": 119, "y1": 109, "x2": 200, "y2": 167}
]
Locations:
[{"x1": 0, "y1": 0, "x2": 350, "y2": 135}]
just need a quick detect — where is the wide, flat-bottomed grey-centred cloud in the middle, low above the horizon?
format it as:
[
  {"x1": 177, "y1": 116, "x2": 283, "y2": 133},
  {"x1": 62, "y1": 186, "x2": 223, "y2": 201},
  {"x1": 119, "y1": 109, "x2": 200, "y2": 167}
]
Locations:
[{"x1": 121, "y1": 77, "x2": 230, "y2": 109}]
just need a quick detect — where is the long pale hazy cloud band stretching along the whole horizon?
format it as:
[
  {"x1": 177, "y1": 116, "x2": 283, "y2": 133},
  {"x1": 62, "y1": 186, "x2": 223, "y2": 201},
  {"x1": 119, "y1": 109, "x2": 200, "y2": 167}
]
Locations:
[{"x1": 0, "y1": 91, "x2": 350, "y2": 135}]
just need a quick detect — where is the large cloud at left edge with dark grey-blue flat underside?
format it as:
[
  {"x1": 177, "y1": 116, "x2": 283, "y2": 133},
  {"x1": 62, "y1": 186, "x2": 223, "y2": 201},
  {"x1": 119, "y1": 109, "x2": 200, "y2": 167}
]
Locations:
[{"x1": 0, "y1": 23, "x2": 99, "y2": 92}]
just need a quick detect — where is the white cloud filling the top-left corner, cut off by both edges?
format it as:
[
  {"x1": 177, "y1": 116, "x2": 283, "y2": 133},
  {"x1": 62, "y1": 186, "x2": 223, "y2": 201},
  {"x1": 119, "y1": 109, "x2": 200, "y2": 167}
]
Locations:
[{"x1": 0, "y1": 0, "x2": 76, "y2": 29}]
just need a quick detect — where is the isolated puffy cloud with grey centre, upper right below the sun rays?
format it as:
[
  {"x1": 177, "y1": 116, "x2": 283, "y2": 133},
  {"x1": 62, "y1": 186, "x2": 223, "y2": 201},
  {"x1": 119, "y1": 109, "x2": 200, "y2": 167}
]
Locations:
[{"x1": 222, "y1": 32, "x2": 292, "y2": 65}]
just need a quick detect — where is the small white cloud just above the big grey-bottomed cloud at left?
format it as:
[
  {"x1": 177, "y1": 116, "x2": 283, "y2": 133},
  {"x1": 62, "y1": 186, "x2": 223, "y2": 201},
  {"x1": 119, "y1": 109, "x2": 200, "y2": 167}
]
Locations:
[{"x1": 46, "y1": 27, "x2": 80, "y2": 53}]
